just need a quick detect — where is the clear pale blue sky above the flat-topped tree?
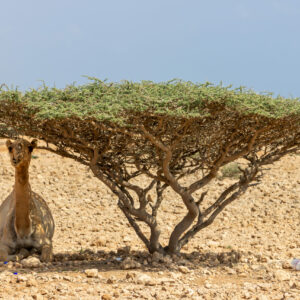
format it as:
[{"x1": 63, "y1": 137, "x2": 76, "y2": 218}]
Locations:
[{"x1": 0, "y1": 0, "x2": 300, "y2": 97}]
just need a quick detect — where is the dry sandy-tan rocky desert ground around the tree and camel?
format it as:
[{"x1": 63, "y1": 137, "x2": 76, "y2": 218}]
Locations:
[{"x1": 0, "y1": 140, "x2": 300, "y2": 300}]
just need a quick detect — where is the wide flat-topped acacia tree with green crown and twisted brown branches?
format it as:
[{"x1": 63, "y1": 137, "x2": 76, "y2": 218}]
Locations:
[{"x1": 0, "y1": 79, "x2": 300, "y2": 253}]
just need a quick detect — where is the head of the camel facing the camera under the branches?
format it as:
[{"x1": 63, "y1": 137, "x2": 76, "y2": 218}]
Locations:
[{"x1": 6, "y1": 139, "x2": 37, "y2": 168}]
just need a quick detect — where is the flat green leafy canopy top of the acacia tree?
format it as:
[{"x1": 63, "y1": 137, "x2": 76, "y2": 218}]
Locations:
[{"x1": 0, "y1": 78, "x2": 300, "y2": 123}]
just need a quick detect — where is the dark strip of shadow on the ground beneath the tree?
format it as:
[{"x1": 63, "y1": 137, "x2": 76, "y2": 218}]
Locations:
[{"x1": 0, "y1": 247, "x2": 242, "y2": 274}]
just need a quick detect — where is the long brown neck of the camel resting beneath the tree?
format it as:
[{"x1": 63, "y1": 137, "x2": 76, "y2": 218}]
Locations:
[{"x1": 14, "y1": 166, "x2": 30, "y2": 237}]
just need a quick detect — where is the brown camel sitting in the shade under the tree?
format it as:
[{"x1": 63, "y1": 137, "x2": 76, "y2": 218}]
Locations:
[{"x1": 0, "y1": 139, "x2": 54, "y2": 262}]
